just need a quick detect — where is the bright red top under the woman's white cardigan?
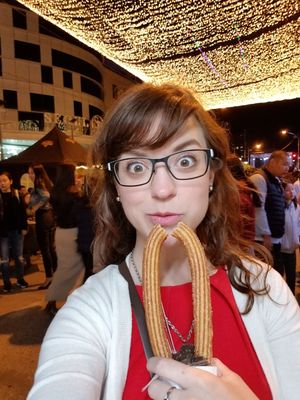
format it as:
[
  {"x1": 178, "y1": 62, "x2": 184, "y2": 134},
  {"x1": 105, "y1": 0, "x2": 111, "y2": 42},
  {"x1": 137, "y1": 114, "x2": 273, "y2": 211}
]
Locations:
[{"x1": 123, "y1": 269, "x2": 272, "y2": 400}]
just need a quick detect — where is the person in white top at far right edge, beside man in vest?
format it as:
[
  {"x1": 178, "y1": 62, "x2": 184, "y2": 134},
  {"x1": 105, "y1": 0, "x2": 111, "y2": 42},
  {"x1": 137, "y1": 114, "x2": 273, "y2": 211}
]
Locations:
[{"x1": 281, "y1": 182, "x2": 300, "y2": 294}]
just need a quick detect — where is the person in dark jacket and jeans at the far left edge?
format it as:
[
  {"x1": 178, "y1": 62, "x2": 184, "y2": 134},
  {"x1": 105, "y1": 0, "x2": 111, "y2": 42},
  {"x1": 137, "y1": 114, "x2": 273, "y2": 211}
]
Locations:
[{"x1": 0, "y1": 171, "x2": 28, "y2": 293}]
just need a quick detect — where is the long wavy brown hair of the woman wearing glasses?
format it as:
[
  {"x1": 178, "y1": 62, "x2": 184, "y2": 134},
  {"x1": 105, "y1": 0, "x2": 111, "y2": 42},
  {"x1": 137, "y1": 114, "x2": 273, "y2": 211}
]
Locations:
[{"x1": 93, "y1": 84, "x2": 267, "y2": 312}]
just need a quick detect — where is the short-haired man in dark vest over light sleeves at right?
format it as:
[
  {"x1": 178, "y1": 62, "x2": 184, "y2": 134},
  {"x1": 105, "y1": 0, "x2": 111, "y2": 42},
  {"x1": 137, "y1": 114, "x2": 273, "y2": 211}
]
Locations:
[{"x1": 250, "y1": 150, "x2": 289, "y2": 275}]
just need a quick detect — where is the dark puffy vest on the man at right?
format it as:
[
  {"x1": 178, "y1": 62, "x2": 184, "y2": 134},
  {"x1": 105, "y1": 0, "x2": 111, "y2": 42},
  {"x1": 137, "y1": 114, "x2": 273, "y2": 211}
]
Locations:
[{"x1": 259, "y1": 168, "x2": 285, "y2": 238}]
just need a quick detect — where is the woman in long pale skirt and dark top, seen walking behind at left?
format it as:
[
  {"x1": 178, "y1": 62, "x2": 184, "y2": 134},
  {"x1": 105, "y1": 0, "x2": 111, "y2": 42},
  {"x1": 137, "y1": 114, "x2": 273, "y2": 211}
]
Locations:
[{"x1": 46, "y1": 165, "x2": 84, "y2": 316}]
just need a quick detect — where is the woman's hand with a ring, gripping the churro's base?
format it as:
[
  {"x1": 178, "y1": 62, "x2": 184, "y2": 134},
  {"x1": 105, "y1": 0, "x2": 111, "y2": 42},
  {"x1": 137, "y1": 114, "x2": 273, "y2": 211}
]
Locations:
[{"x1": 147, "y1": 357, "x2": 259, "y2": 400}]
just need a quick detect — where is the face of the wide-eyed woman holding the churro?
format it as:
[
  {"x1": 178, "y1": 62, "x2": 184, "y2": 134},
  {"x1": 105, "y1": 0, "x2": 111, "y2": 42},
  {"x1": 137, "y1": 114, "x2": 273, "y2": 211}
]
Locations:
[{"x1": 116, "y1": 117, "x2": 214, "y2": 242}]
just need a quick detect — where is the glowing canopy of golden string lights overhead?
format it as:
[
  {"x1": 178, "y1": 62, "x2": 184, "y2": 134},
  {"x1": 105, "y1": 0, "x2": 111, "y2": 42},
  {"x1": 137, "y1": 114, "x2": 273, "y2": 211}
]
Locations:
[{"x1": 20, "y1": 0, "x2": 300, "y2": 108}]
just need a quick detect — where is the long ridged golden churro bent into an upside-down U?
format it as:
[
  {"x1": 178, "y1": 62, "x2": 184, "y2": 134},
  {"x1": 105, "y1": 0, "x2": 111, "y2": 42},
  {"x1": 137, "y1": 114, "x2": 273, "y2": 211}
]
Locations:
[{"x1": 143, "y1": 222, "x2": 212, "y2": 363}]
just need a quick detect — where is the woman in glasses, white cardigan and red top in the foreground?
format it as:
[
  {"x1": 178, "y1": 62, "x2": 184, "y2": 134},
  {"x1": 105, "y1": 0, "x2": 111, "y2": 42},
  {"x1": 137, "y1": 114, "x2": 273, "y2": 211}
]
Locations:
[{"x1": 29, "y1": 84, "x2": 300, "y2": 400}]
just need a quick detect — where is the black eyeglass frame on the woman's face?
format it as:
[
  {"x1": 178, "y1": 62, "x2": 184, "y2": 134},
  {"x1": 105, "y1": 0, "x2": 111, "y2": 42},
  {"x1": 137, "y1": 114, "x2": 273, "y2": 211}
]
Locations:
[{"x1": 106, "y1": 149, "x2": 214, "y2": 187}]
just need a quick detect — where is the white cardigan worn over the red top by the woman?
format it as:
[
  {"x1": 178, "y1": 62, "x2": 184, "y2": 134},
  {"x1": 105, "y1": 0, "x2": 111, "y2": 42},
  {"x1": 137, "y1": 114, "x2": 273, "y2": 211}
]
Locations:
[{"x1": 27, "y1": 263, "x2": 300, "y2": 400}]
